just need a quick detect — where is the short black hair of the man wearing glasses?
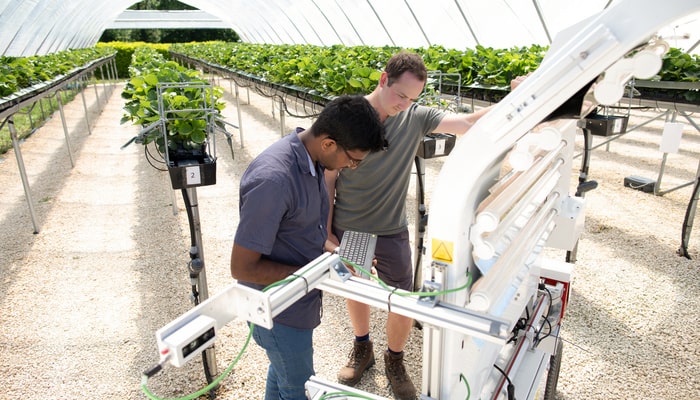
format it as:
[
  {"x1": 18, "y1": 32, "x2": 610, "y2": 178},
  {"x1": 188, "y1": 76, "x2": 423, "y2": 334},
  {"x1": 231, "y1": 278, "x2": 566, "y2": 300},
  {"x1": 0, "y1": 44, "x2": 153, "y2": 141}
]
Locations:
[{"x1": 311, "y1": 95, "x2": 386, "y2": 152}]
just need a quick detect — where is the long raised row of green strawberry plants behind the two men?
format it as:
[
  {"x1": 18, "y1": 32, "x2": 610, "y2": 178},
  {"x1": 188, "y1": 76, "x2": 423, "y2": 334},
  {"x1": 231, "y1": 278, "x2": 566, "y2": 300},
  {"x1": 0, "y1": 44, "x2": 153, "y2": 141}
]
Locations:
[{"x1": 171, "y1": 42, "x2": 700, "y2": 102}]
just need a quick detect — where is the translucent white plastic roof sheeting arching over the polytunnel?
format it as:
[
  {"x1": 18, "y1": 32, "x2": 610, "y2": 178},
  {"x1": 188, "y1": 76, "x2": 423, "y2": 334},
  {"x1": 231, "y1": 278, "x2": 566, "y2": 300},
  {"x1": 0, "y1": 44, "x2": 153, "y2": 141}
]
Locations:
[{"x1": 0, "y1": 0, "x2": 700, "y2": 56}]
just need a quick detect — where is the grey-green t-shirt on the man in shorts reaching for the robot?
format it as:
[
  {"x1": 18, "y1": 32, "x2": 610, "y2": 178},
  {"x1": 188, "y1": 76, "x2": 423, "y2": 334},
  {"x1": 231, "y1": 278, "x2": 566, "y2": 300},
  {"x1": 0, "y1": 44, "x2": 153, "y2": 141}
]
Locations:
[{"x1": 333, "y1": 104, "x2": 445, "y2": 235}]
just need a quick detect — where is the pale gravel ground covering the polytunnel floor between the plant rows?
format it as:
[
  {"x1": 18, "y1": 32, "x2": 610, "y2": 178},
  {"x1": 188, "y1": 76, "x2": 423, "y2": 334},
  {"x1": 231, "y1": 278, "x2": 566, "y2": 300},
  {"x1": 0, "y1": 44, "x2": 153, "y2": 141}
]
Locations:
[{"x1": 0, "y1": 79, "x2": 700, "y2": 400}]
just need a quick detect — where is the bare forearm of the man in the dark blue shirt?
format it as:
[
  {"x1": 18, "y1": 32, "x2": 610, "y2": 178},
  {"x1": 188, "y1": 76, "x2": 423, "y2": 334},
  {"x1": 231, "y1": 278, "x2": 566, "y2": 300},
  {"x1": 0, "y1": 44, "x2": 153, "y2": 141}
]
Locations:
[{"x1": 231, "y1": 243, "x2": 301, "y2": 285}]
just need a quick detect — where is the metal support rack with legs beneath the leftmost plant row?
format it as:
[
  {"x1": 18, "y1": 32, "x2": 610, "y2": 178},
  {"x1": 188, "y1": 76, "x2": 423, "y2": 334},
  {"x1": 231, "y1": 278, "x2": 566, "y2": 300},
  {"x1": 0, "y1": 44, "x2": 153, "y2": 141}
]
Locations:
[{"x1": 0, "y1": 53, "x2": 117, "y2": 234}]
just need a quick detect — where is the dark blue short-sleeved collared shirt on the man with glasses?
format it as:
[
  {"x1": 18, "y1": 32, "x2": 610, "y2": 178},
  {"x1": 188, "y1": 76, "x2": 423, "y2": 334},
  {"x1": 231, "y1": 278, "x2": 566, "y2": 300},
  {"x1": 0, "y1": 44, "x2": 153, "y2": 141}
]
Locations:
[{"x1": 234, "y1": 128, "x2": 329, "y2": 329}]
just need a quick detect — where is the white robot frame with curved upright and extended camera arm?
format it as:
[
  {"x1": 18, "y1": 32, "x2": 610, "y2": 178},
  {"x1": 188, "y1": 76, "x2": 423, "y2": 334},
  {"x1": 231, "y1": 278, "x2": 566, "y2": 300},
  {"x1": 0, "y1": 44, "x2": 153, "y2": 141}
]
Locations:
[{"x1": 148, "y1": 0, "x2": 700, "y2": 399}]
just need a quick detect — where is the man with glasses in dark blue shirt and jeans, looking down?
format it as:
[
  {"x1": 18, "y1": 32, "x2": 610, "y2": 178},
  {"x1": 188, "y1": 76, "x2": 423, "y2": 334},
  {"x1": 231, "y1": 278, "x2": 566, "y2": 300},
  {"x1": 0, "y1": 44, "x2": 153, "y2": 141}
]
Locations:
[{"x1": 231, "y1": 96, "x2": 384, "y2": 400}]
